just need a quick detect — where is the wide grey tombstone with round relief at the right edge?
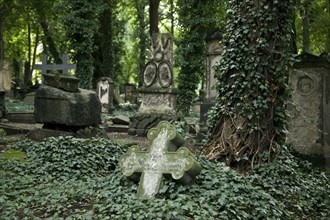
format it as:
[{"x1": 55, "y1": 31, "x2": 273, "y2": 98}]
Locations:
[{"x1": 288, "y1": 53, "x2": 330, "y2": 174}]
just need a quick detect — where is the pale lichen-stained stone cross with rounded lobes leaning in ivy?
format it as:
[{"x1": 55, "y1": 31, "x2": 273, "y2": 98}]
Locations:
[{"x1": 119, "y1": 121, "x2": 201, "y2": 197}]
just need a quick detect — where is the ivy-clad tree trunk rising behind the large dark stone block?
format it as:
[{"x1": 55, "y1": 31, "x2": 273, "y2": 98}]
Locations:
[{"x1": 61, "y1": 0, "x2": 102, "y2": 89}]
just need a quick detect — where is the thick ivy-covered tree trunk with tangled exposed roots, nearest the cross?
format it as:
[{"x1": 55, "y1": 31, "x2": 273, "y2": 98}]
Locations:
[{"x1": 203, "y1": 0, "x2": 294, "y2": 167}]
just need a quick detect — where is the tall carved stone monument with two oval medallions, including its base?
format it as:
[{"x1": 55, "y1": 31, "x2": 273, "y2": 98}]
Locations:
[{"x1": 128, "y1": 33, "x2": 177, "y2": 136}]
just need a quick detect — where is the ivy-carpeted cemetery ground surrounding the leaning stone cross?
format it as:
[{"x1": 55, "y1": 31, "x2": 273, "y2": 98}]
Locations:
[{"x1": 0, "y1": 100, "x2": 330, "y2": 219}]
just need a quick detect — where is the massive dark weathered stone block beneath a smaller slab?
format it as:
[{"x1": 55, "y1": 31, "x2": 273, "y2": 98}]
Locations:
[{"x1": 35, "y1": 86, "x2": 101, "y2": 126}]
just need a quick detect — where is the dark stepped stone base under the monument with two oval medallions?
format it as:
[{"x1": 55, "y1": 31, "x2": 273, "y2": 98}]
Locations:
[{"x1": 127, "y1": 113, "x2": 177, "y2": 136}]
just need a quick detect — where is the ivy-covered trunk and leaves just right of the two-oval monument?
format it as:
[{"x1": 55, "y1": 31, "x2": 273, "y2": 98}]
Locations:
[{"x1": 176, "y1": 0, "x2": 224, "y2": 115}]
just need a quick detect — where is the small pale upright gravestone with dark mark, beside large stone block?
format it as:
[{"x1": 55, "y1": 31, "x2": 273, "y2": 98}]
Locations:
[{"x1": 96, "y1": 77, "x2": 114, "y2": 113}]
